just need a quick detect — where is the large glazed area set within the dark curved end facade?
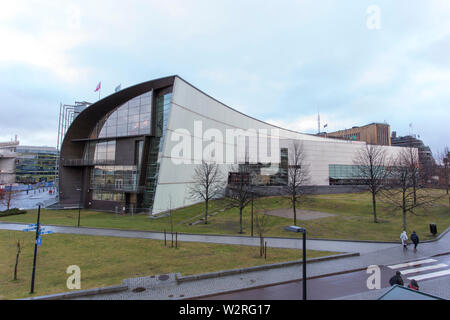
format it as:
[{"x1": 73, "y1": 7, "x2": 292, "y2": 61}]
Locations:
[{"x1": 83, "y1": 91, "x2": 172, "y2": 208}]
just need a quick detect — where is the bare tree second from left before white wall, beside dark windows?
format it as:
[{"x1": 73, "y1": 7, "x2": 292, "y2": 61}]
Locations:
[{"x1": 226, "y1": 164, "x2": 252, "y2": 233}]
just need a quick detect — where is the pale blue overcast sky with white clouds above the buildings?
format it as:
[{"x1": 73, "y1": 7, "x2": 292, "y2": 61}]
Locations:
[{"x1": 0, "y1": 0, "x2": 450, "y2": 156}]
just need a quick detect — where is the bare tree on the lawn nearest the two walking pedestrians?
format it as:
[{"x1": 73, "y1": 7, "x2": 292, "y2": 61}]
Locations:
[{"x1": 381, "y1": 147, "x2": 440, "y2": 230}]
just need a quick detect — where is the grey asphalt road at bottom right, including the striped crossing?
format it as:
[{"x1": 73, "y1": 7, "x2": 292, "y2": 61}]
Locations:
[{"x1": 199, "y1": 255, "x2": 450, "y2": 300}]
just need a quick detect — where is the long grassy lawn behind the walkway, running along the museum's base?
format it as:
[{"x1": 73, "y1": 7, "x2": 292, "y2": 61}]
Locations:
[{"x1": 0, "y1": 191, "x2": 450, "y2": 241}]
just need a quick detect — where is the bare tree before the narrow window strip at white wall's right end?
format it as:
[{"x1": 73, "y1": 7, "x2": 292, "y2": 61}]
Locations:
[{"x1": 353, "y1": 144, "x2": 388, "y2": 223}]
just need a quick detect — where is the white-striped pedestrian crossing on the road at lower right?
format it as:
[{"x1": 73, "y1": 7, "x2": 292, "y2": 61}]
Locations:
[{"x1": 387, "y1": 259, "x2": 450, "y2": 281}]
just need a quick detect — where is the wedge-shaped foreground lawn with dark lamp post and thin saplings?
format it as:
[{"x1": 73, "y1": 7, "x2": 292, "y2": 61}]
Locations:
[{"x1": 0, "y1": 231, "x2": 335, "y2": 299}]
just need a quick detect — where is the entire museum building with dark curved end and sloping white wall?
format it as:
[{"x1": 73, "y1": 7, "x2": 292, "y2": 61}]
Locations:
[{"x1": 59, "y1": 76, "x2": 410, "y2": 213}]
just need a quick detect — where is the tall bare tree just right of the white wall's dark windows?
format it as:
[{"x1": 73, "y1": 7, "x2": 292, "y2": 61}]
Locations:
[{"x1": 287, "y1": 141, "x2": 310, "y2": 225}]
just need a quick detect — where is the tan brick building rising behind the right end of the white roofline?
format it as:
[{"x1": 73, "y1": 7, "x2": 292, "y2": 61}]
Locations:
[{"x1": 319, "y1": 123, "x2": 391, "y2": 146}]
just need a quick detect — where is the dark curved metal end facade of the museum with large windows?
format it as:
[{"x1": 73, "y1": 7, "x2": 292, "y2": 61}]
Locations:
[{"x1": 59, "y1": 76, "x2": 175, "y2": 211}]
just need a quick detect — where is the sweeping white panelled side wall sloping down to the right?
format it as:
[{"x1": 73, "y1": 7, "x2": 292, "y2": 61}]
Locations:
[{"x1": 153, "y1": 77, "x2": 410, "y2": 213}]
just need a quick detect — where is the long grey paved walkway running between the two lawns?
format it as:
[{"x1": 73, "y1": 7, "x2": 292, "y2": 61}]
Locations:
[{"x1": 0, "y1": 222, "x2": 398, "y2": 253}]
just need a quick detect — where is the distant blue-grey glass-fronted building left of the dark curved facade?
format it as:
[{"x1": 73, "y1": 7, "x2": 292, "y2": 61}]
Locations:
[{"x1": 16, "y1": 146, "x2": 58, "y2": 184}]
